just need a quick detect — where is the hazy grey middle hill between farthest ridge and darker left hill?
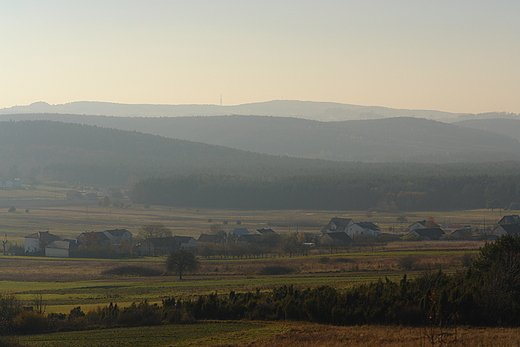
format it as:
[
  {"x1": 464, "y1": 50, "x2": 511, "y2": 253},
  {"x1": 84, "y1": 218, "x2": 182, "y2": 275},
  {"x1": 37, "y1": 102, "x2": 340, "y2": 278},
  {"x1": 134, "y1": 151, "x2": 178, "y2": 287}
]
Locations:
[{"x1": 0, "y1": 114, "x2": 520, "y2": 163}]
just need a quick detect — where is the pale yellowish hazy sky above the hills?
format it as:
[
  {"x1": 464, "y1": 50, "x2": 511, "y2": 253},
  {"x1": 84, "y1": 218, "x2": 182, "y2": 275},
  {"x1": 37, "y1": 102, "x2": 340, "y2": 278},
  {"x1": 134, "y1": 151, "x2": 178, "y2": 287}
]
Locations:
[{"x1": 0, "y1": 0, "x2": 520, "y2": 113}]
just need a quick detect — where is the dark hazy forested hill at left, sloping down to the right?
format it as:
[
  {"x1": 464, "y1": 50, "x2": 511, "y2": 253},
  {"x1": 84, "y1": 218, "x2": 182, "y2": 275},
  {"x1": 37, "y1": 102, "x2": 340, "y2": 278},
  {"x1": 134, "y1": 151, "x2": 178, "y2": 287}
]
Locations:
[{"x1": 0, "y1": 121, "x2": 358, "y2": 185}]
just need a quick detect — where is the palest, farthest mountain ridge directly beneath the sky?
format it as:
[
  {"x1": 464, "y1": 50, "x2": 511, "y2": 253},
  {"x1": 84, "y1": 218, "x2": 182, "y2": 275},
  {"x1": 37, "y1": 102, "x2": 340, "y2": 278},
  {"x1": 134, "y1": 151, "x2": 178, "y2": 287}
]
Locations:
[{"x1": 0, "y1": 100, "x2": 461, "y2": 121}]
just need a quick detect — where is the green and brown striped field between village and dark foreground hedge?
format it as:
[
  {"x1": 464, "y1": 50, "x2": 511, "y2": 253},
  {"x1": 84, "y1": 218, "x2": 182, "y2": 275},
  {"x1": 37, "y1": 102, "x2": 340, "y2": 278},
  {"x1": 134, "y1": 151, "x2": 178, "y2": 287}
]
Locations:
[{"x1": 0, "y1": 241, "x2": 481, "y2": 313}]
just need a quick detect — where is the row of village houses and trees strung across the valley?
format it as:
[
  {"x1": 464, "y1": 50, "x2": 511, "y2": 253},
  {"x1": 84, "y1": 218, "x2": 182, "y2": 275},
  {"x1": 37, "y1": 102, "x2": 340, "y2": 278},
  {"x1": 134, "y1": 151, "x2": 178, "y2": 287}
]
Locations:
[{"x1": 18, "y1": 214, "x2": 520, "y2": 258}]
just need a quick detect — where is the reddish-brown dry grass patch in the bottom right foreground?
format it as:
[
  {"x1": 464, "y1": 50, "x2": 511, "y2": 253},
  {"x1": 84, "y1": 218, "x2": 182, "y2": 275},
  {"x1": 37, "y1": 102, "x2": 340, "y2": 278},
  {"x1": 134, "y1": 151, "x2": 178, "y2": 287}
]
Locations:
[{"x1": 215, "y1": 324, "x2": 520, "y2": 347}]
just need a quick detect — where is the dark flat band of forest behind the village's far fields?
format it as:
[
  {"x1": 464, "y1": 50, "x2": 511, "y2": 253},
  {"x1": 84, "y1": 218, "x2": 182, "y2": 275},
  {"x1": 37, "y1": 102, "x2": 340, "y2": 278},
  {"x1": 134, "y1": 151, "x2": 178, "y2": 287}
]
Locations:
[{"x1": 132, "y1": 171, "x2": 520, "y2": 211}]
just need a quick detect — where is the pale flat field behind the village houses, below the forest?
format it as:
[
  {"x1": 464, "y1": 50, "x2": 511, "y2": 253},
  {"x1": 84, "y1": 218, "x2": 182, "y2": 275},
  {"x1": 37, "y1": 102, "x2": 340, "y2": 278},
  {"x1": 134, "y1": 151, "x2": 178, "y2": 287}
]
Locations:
[{"x1": 0, "y1": 186, "x2": 502, "y2": 244}]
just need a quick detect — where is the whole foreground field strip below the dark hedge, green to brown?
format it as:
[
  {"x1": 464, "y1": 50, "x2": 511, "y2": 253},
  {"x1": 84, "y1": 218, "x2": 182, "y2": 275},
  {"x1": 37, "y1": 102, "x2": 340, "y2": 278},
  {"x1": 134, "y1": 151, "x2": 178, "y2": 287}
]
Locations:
[{"x1": 13, "y1": 322, "x2": 520, "y2": 347}]
